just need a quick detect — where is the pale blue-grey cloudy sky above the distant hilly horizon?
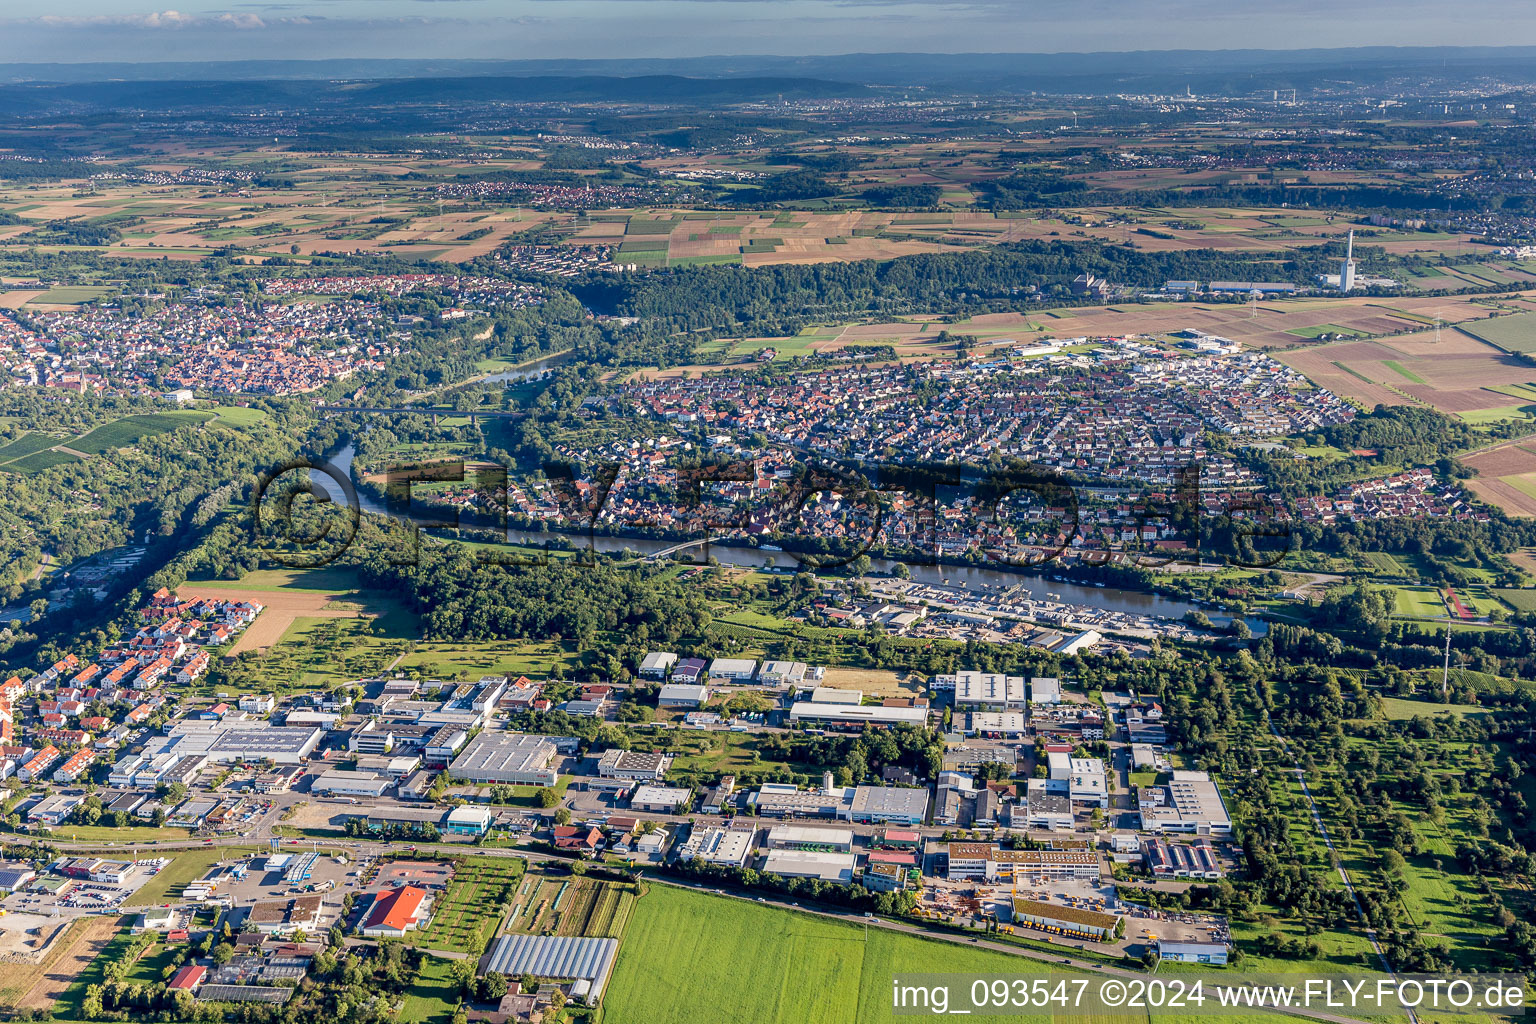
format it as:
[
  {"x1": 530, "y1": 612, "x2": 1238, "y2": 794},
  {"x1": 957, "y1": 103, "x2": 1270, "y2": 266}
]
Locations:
[{"x1": 0, "y1": 0, "x2": 1536, "y2": 63}]
